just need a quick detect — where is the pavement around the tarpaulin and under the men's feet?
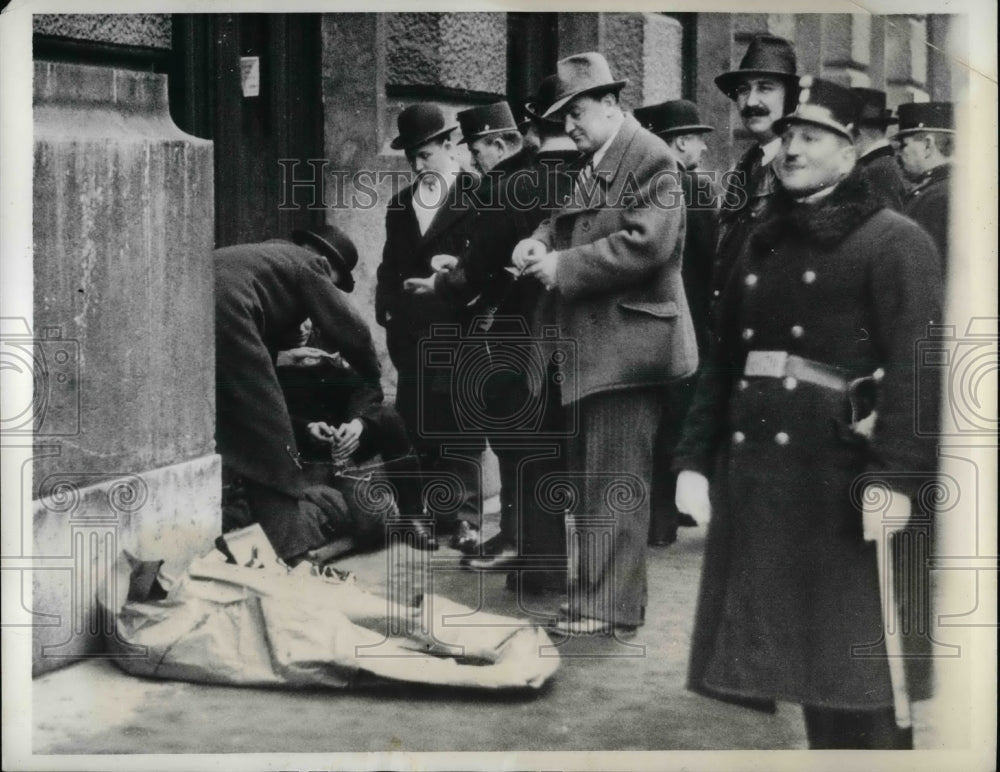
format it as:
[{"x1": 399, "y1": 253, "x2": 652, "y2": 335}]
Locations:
[{"x1": 32, "y1": 525, "x2": 927, "y2": 754}]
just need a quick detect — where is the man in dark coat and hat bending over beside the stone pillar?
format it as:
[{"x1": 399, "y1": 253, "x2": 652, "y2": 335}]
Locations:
[{"x1": 213, "y1": 225, "x2": 438, "y2": 562}]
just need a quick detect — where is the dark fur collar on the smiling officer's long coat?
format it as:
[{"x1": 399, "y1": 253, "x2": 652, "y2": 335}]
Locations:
[{"x1": 751, "y1": 168, "x2": 885, "y2": 251}]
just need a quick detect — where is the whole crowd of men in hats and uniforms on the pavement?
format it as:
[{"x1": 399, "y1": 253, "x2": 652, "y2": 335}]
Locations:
[{"x1": 215, "y1": 35, "x2": 954, "y2": 748}]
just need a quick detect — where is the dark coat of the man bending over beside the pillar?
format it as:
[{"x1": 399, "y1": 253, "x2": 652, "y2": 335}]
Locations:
[{"x1": 213, "y1": 239, "x2": 380, "y2": 496}]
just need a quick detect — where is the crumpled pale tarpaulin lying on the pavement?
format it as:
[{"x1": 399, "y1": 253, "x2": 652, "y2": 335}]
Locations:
[{"x1": 109, "y1": 533, "x2": 559, "y2": 689}]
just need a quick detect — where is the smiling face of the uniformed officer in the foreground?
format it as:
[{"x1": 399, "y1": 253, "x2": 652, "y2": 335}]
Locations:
[{"x1": 774, "y1": 123, "x2": 855, "y2": 197}]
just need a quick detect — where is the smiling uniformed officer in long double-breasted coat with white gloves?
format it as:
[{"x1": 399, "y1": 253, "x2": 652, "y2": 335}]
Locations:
[{"x1": 675, "y1": 76, "x2": 942, "y2": 748}]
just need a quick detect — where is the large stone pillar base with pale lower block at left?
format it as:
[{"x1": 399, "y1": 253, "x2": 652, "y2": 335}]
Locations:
[{"x1": 28, "y1": 62, "x2": 220, "y2": 672}]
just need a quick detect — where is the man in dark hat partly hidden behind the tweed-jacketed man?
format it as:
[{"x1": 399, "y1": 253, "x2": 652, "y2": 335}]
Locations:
[{"x1": 633, "y1": 99, "x2": 718, "y2": 546}]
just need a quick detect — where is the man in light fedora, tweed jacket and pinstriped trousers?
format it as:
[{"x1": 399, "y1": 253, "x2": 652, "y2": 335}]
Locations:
[{"x1": 513, "y1": 53, "x2": 698, "y2": 635}]
